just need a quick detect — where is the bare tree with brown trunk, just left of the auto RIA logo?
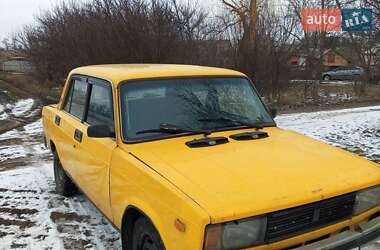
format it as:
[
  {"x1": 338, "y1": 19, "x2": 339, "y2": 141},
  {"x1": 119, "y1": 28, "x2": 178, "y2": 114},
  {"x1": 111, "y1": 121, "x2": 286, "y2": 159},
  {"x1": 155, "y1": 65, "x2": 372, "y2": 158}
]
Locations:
[{"x1": 221, "y1": 0, "x2": 296, "y2": 100}]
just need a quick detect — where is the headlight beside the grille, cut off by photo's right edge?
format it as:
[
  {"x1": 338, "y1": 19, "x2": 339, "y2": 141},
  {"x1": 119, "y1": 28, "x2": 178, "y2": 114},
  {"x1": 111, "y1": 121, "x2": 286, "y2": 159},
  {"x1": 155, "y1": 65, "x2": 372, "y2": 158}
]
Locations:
[{"x1": 354, "y1": 186, "x2": 380, "y2": 215}]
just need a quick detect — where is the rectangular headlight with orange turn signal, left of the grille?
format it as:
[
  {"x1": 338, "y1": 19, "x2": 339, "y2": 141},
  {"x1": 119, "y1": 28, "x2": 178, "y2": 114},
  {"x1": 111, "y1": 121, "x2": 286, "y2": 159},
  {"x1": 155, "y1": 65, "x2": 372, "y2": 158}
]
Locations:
[{"x1": 204, "y1": 217, "x2": 267, "y2": 250}]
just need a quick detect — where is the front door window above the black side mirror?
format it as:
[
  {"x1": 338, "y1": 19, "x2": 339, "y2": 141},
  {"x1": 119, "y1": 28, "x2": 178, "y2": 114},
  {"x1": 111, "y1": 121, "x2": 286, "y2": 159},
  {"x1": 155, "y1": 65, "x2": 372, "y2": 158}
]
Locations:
[{"x1": 87, "y1": 84, "x2": 114, "y2": 128}]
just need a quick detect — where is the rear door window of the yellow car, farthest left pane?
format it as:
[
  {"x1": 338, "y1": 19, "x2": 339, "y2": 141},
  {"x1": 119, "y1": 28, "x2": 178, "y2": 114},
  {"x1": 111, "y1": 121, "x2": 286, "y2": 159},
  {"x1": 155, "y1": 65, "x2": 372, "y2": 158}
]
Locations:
[{"x1": 64, "y1": 79, "x2": 87, "y2": 120}]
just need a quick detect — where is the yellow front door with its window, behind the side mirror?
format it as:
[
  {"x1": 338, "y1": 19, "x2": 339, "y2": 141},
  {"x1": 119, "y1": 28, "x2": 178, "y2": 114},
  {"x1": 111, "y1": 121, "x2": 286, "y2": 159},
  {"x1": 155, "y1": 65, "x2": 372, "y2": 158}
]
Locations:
[{"x1": 78, "y1": 78, "x2": 117, "y2": 220}]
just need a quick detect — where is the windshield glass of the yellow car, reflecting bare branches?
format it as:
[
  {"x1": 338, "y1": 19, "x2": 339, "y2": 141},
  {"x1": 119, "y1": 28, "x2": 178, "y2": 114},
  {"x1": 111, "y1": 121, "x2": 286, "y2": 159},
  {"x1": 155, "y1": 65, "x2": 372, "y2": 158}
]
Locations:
[{"x1": 120, "y1": 77, "x2": 275, "y2": 141}]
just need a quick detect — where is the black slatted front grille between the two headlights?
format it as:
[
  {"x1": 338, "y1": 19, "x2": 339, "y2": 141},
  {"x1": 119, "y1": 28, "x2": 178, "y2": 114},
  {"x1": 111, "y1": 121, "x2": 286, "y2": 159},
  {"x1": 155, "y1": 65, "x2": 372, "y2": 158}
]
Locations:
[{"x1": 266, "y1": 193, "x2": 355, "y2": 242}]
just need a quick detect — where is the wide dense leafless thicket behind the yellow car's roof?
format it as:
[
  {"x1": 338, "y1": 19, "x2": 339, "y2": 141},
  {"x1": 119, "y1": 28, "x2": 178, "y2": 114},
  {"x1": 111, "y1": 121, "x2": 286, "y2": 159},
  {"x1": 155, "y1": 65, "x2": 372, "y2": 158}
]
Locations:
[{"x1": 14, "y1": 0, "x2": 206, "y2": 80}]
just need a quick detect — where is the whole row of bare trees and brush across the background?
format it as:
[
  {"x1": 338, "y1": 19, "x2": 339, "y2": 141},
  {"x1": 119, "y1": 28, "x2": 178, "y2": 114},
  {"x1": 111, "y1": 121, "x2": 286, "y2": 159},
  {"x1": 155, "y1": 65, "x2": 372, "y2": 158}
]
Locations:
[{"x1": 8, "y1": 0, "x2": 380, "y2": 99}]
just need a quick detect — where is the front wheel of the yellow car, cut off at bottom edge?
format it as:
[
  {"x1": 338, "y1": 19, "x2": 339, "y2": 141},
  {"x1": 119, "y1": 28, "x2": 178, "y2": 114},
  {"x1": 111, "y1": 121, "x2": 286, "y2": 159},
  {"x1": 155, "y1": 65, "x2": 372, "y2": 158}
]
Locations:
[{"x1": 132, "y1": 217, "x2": 165, "y2": 250}]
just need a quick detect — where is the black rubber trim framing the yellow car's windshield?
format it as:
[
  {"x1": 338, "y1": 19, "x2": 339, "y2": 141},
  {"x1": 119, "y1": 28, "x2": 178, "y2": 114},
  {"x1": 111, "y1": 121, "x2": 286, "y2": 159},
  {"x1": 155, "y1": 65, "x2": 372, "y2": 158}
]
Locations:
[{"x1": 117, "y1": 75, "x2": 277, "y2": 144}]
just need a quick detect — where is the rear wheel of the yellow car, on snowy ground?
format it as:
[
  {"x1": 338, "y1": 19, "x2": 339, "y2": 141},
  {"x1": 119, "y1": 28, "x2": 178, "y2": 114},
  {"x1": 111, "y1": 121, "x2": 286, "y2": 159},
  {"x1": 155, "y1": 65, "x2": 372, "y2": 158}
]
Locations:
[{"x1": 54, "y1": 152, "x2": 77, "y2": 197}]
